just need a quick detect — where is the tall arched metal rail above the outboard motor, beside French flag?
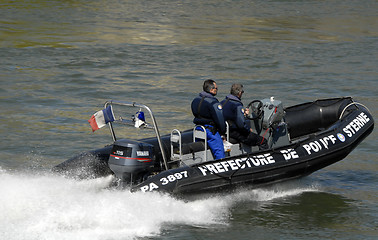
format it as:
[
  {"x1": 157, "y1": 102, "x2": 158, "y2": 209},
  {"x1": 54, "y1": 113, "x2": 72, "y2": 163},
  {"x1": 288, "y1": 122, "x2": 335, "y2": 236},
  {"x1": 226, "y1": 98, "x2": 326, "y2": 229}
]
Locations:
[{"x1": 105, "y1": 100, "x2": 168, "y2": 170}]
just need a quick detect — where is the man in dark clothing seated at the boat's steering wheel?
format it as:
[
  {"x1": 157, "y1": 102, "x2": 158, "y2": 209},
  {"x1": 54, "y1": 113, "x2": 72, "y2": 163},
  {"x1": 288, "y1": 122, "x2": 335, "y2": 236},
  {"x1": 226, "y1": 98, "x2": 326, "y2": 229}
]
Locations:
[{"x1": 221, "y1": 83, "x2": 268, "y2": 149}]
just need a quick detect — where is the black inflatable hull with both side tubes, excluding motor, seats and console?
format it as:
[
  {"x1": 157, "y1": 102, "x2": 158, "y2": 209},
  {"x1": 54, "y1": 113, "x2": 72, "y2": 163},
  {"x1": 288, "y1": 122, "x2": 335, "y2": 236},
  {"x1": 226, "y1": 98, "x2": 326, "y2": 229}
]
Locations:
[{"x1": 53, "y1": 97, "x2": 374, "y2": 194}]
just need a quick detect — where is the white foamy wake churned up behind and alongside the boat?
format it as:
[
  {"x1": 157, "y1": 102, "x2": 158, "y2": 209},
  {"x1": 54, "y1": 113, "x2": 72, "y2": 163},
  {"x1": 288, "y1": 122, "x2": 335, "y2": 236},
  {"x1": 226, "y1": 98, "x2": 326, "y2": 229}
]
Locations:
[{"x1": 0, "y1": 167, "x2": 315, "y2": 240}]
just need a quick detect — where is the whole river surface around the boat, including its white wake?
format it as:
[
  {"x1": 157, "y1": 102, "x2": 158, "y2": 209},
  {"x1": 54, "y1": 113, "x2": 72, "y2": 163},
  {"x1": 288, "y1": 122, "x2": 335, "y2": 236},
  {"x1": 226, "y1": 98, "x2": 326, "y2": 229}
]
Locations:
[{"x1": 0, "y1": 0, "x2": 378, "y2": 239}]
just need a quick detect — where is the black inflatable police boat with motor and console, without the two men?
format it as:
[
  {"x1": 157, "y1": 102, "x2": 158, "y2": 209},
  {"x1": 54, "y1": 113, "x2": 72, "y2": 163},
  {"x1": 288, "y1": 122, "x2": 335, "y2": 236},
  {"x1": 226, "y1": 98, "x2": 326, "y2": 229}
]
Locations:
[{"x1": 53, "y1": 97, "x2": 374, "y2": 194}]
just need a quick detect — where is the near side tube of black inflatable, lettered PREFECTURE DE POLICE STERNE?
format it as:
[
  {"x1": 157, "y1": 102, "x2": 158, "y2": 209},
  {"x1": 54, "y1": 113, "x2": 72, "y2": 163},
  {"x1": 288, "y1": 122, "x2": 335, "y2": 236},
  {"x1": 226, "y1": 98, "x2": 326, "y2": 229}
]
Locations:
[{"x1": 131, "y1": 107, "x2": 374, "y2": 194}]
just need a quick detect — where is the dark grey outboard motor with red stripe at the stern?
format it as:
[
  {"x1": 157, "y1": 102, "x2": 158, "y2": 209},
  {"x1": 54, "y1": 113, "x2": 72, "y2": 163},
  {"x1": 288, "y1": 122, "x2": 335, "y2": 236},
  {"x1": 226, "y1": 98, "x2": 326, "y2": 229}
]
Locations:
[{"x1": 108, "y1": 140, "x2": 155, "y2": 184}]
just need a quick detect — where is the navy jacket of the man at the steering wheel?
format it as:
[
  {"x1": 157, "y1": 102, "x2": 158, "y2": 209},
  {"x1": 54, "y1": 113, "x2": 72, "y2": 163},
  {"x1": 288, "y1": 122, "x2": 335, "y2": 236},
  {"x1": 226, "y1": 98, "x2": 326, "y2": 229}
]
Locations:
[{"x1": 221, "y1": 94, "x2": 250, "y2": 134}]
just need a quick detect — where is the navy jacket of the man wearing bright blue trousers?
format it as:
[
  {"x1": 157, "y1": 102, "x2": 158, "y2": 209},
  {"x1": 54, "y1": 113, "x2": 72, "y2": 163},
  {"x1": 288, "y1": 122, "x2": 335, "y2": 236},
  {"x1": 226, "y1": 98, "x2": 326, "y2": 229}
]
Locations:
[{"x1": 192, "y1": 92, "x2": 226, "y2": 134}]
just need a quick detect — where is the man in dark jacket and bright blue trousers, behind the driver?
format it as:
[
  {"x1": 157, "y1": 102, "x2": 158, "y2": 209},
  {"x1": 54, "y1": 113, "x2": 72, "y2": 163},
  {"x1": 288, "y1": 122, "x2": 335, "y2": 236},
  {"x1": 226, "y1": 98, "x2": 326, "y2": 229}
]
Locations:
[{"x1": 191, "y1": 79, "x2": 226, "y2": 159}]
